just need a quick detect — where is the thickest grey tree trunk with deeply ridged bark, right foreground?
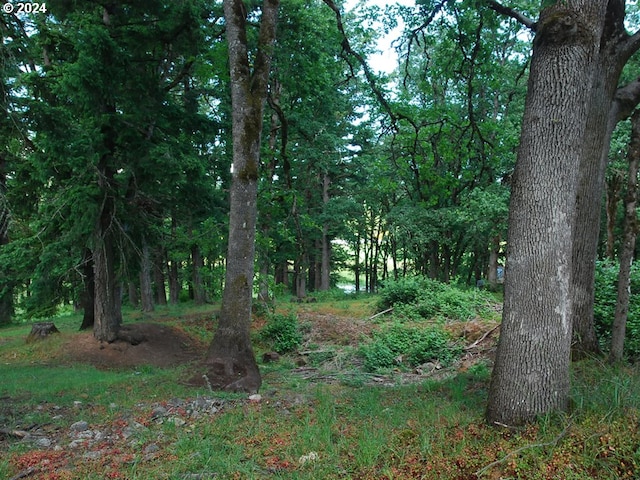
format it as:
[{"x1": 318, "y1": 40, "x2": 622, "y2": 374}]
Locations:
[{"x1": 487, "y1": 0, "x2": 608, "y2": 425}]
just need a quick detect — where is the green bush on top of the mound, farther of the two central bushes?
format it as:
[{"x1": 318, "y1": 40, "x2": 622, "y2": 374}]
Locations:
[{"x1": 377, "y1": 277, "x2": 493, "y2": 320}]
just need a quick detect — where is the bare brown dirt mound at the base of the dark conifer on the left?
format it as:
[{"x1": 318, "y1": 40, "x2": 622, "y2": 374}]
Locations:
[{"x1": 64, "y1": 323, "x2": 206, "y2": 368}]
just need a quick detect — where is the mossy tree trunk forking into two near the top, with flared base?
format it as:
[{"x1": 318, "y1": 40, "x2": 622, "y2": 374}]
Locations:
[{"x1": 206, "y1": 0, "x2": 279, "y2": 392}]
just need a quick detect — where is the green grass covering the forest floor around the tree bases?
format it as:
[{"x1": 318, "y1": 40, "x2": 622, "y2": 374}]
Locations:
[{"x1": 0, "y1": 296, "x2": 640, "y2": 480}]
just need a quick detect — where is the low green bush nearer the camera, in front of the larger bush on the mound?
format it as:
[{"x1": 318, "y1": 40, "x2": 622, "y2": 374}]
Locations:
[{"x1": 360, "y1": 323, "x2": 462, "y2": 372}]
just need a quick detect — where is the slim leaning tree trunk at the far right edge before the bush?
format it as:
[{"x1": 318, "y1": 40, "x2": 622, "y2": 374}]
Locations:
[{"x1": 609, "y1": 111, "x2": 640, "y2": 363}]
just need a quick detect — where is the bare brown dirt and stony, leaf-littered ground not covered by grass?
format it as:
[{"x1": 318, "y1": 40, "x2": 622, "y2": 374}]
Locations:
[{"x1": 0, "y1": 309, "x2": 497, "y2": 480}]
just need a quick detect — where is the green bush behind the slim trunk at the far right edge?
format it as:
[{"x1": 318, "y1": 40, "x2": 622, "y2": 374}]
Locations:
[{"x1": 593, "y1": 261, "x2": 640, "y2": 358}]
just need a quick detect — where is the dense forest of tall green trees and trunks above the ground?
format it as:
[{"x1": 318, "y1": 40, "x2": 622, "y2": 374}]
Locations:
[{"x1": 0, "y1": 0, "x2": 640, "y2": 458}]
